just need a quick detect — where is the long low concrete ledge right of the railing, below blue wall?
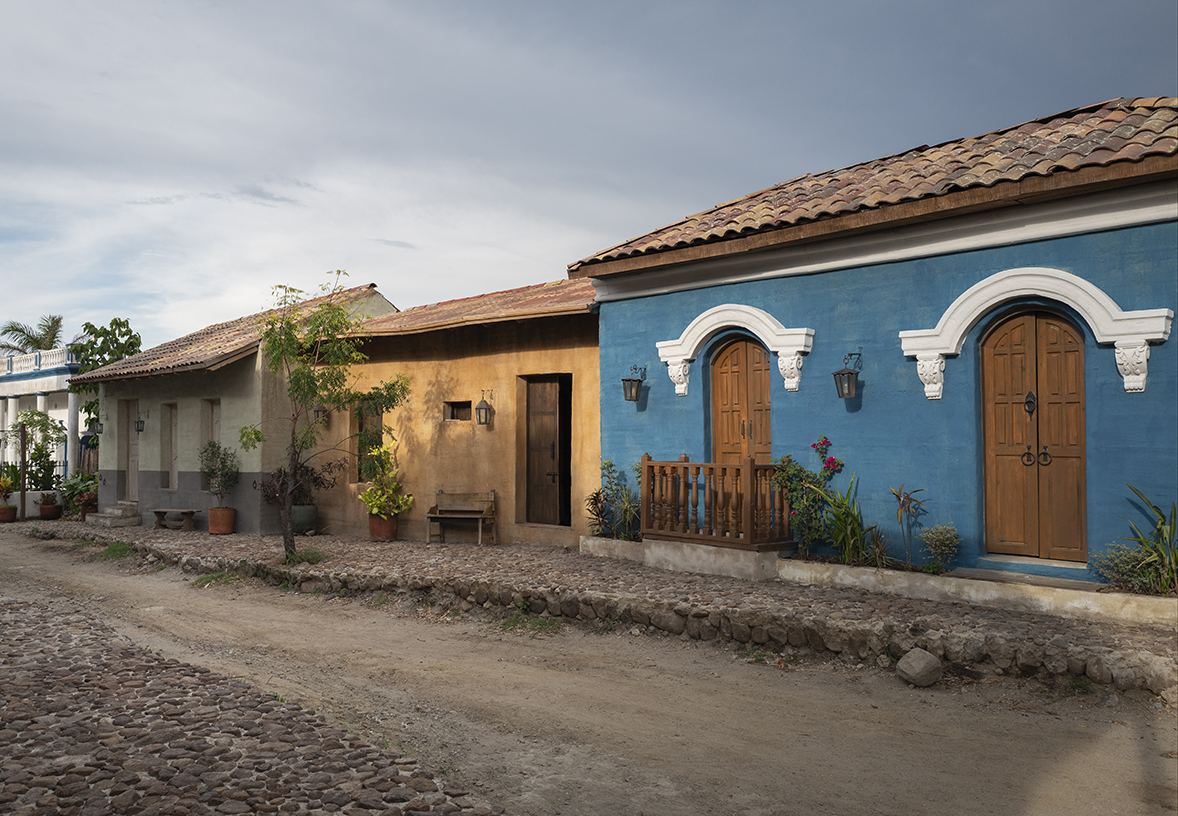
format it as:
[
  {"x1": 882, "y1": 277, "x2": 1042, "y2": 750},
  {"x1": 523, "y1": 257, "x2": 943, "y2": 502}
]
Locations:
[{"x1": 777, "y1": 558, "x2": 1178, "y2": 629}]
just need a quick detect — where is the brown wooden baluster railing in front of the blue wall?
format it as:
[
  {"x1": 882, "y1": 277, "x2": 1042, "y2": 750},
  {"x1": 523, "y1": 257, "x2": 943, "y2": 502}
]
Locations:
[{"x1": 641, "y1": 455, "x2": 792, "y2": 552}]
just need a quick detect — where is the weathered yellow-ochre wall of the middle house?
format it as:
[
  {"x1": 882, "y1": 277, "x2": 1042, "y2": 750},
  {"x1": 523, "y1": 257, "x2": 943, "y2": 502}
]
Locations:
[{"x1": 318, "y1": 314, "x2": 601, "y2": 546}]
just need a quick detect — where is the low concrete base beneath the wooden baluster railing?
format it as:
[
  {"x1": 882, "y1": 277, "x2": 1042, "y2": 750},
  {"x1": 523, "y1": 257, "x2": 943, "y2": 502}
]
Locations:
[{"x1": 581, "y1": 536, "x2": 777, "y2": 581}]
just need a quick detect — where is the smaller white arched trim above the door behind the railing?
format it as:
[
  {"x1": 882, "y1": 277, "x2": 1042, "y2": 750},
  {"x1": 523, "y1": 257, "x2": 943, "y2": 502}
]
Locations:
[{"x1": 655, "y1": 303, "x2": 814, "y2": 397}]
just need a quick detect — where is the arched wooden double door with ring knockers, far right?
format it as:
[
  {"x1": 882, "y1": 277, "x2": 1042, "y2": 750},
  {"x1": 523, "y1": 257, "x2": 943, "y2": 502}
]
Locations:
[{"x1": 981, "y1": 312, "x2": 1087, "y2": 562}]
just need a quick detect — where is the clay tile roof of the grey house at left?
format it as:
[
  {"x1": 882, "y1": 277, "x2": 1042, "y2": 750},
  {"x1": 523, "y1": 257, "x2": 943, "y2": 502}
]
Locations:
[{"x1": 70, "y1": 284, "x2": 379, "y2": 384}]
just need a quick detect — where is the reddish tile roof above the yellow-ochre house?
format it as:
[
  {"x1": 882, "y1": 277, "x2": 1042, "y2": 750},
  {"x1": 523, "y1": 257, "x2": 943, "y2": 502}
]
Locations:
[{"x1": 364, "y1": 279, "x2": 594, "y2": 334}]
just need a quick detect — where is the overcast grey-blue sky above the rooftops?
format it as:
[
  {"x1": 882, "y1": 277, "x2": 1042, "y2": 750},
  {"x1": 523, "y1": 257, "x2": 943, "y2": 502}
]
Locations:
[{"x1": 0, "y1": 0, "x2": 1178, "y2": 347}]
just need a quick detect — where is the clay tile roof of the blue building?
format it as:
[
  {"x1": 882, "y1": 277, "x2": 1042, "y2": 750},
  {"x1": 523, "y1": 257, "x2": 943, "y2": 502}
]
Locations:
[{"x1": 569, "y1": 97, "x2": 1178, "y2": 274}]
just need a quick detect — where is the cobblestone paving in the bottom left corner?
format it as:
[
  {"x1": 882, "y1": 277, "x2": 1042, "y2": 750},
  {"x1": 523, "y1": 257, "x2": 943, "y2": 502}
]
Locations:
[{"x1": 0, "y1": 598, "x2": 503, "y2": 816}]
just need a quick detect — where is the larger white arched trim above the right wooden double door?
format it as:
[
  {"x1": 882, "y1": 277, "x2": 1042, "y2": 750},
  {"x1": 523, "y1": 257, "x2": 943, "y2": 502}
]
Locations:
[{"x1": 900, "y1": 266, "x2": 1174, "y2": 399}]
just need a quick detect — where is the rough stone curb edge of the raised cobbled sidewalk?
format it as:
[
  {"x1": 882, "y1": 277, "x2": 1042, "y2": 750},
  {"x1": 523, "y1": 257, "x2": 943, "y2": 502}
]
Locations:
[{"x1": 59, "y1": 522, "x2": 1178, "y2": 694}]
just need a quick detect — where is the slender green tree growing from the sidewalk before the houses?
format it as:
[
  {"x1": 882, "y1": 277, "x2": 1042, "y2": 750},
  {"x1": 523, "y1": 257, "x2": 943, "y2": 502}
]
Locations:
[{"x1": 240, "y1": 271, "x2": 409, "y2": 562}]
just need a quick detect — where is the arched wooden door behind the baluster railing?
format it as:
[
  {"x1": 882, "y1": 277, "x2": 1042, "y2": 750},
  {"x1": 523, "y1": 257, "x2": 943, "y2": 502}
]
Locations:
[{"x1": 712, "y1": 340, "x2": 773, "y2": 464}]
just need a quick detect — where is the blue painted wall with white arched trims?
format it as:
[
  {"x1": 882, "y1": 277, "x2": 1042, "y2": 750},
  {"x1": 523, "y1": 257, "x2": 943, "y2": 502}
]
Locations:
[{"x1": 600, "y1": 223, "x2": 1178, "y2": 566}]
